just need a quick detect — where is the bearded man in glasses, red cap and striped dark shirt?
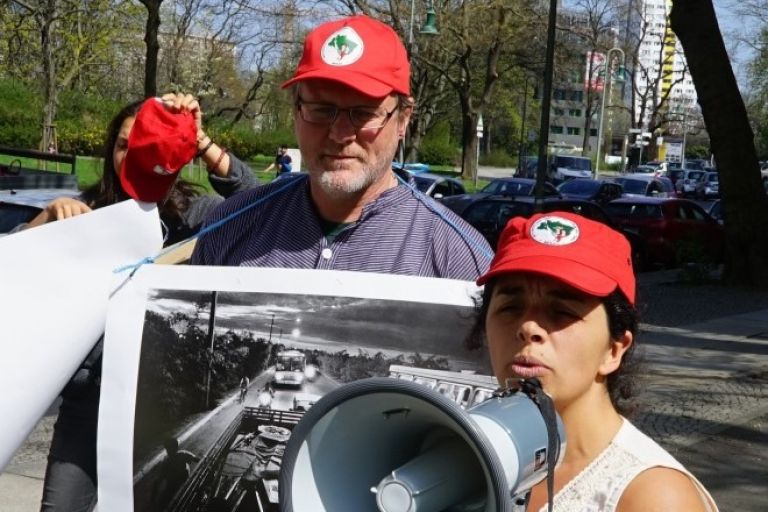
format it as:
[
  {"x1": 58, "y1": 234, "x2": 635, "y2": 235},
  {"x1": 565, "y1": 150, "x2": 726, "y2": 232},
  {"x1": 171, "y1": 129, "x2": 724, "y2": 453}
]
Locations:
[{"x1": 192, "y1": 16, "x2": 492, "y2": 280}]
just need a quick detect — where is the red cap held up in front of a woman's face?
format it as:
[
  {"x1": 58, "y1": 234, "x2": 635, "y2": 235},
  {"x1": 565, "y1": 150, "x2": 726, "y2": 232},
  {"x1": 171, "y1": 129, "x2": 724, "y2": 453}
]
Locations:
[{"x1": 120, "y1": 98, "x2": 197, "y2": 203}]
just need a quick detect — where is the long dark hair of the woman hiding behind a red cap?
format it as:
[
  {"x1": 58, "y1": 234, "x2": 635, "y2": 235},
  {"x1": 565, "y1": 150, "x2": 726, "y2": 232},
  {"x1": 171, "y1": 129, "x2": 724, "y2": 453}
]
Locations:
[{"x1": 83, "y1": 100, "x2": 201, "y2": 224}]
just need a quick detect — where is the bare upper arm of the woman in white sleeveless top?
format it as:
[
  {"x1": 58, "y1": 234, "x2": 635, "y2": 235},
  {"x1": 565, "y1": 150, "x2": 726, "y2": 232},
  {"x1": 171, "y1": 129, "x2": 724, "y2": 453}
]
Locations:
[{"x1": 616, "y1": 467, "x2": 716, "y2": 512}]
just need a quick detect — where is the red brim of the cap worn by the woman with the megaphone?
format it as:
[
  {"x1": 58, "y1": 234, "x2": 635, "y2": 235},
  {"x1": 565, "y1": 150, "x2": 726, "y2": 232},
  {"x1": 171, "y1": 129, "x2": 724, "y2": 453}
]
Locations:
[{"x1": 477, "y1": 256, "x2": 619, "y2": 297}]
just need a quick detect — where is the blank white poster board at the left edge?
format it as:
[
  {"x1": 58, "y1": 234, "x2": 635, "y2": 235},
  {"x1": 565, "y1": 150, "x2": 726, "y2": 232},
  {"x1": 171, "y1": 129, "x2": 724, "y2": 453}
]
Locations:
[{"x1": 0, "y1": 201, "x2": 162, "y2": 468}]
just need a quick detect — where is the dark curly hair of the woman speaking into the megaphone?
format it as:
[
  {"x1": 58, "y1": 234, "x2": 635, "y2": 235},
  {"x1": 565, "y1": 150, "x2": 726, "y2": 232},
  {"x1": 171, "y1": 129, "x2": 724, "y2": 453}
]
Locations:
[{"x1": 465, "y1": 279, "x2": 640, "y2": 416}]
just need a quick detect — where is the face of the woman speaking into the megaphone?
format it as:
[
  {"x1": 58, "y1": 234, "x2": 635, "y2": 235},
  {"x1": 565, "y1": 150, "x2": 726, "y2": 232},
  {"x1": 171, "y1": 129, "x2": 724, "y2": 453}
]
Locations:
[{"x1": 485, "y1": 274, "x2": 632, "y2": 411}]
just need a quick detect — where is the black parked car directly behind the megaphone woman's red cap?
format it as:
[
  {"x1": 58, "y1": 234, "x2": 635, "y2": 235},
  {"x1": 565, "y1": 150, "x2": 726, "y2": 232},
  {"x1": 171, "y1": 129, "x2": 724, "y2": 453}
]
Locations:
[{"x1": 452, "y1": 196, "x2": 646, "y2": 270}]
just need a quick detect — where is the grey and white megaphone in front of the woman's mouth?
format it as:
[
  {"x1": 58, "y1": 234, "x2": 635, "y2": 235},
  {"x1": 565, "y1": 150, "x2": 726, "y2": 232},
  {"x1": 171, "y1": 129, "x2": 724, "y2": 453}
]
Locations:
[{"x1": 279, "y1": 378, "x2": 565, "y2": 512}]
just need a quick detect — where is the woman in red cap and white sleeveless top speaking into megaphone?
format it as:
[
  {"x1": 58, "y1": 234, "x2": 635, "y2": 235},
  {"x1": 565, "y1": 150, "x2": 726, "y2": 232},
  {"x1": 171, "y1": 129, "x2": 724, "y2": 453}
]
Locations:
[{"x1": 468, "y1": 212, "x2": 717, "y2": 512}]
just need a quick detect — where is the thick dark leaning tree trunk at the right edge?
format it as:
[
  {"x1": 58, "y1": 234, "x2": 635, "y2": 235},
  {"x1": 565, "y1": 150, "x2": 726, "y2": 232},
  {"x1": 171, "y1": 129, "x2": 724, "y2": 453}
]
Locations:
[{"x1": 670, "y1": 0, "x2": 768, "y2": 288}]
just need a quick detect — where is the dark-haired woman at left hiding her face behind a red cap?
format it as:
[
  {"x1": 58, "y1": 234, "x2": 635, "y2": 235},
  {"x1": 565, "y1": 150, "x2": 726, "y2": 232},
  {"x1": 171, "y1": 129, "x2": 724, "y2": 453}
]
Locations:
[{"x1": 32, "y1": 94, "x2": 258, "y2": 512}]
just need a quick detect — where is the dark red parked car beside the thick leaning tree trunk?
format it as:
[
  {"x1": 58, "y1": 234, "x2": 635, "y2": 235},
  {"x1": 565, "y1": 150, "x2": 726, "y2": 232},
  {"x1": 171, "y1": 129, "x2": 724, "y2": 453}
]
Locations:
[{"x1": 605, "y1": 197, "x2": 725, "y2": 268}]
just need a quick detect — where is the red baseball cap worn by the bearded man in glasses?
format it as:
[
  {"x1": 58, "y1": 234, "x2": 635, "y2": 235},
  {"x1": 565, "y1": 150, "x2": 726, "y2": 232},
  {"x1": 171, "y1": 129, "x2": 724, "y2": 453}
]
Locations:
[{"x1": 283, "y1": 16, "x2": 411, "y2": 98}]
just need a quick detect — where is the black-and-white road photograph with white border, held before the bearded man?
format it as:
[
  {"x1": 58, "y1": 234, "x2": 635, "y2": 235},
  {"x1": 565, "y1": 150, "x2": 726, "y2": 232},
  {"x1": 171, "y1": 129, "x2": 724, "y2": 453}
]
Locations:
[{"x1": 99, "y1": 267, "x2": 493, "y2": 512}]
